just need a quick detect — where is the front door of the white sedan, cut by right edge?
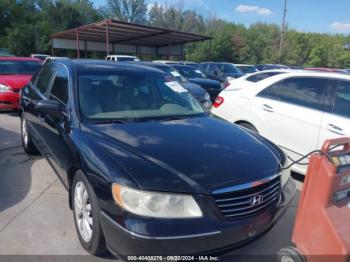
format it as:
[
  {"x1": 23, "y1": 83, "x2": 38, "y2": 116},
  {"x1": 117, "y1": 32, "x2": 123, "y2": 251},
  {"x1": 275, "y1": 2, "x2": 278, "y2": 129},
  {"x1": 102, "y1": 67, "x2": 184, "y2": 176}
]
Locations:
[{"x1": 318, "y1": 80, "x2": 350, "y2": 148}]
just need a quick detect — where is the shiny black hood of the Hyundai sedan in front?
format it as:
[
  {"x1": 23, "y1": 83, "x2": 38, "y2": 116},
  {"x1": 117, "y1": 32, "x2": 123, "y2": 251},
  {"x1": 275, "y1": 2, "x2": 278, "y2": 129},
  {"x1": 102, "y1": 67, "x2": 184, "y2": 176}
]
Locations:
[{"x1": 84, "y1": 116, "x2": 282, "y2": 194}]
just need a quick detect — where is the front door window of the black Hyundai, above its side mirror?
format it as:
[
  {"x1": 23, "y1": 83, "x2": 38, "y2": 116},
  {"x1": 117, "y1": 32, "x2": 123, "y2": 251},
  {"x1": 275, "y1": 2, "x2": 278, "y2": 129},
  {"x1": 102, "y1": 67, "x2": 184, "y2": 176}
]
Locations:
[{"x1": 50, "y1": 64, "x2": 68, "y2": 104}]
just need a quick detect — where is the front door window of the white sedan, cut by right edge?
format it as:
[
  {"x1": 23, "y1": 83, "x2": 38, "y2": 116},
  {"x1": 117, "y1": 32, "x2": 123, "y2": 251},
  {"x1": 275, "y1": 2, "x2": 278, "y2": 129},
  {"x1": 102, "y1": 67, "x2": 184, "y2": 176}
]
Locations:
[{"x1": 333, "y1": 81, "x2": 350, "y2": 118}]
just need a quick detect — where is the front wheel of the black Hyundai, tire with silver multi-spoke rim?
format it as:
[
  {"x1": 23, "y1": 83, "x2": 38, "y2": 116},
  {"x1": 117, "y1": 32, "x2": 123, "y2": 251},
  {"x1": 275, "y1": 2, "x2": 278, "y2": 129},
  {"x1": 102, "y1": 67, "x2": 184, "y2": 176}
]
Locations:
[{"x1": 71, "y1": 171, "x2": 106, "y2": 256}]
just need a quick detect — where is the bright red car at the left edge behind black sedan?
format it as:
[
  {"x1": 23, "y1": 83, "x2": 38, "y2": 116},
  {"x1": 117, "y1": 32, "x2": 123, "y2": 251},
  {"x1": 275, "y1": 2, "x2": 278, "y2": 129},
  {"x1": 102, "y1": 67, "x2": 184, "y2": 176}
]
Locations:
[{"x1": 0, "y1": 57, "x2": 42, "y2": 110}]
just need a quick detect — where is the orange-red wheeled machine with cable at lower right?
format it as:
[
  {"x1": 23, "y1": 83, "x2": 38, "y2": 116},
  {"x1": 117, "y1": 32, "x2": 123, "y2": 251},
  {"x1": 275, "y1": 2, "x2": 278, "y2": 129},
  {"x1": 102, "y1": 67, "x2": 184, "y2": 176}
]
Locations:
[{"x1": 278, "y1": 138, "x2": 350, "y2": 262}]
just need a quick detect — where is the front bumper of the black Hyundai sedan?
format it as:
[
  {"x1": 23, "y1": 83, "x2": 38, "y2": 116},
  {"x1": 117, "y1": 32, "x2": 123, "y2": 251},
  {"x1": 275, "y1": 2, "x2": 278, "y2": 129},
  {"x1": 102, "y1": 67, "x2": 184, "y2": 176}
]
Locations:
[{"x1": 101, "y1": 179, "x2": 296, "y2": 257}]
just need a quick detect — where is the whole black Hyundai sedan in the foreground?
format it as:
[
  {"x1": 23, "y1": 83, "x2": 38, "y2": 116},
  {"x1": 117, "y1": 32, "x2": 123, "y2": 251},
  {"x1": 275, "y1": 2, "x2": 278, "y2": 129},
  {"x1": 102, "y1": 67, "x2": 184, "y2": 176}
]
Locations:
[{"x1": 20, "y1": 60, "x2": 295, "y2": 256}]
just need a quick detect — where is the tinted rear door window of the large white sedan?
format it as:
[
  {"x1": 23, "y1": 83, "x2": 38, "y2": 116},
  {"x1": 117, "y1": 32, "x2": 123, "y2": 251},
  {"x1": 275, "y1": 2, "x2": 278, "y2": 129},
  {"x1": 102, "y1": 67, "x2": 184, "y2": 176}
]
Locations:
[{"x1": 279, "y1": 77, "x2": 328, "y2": 109}]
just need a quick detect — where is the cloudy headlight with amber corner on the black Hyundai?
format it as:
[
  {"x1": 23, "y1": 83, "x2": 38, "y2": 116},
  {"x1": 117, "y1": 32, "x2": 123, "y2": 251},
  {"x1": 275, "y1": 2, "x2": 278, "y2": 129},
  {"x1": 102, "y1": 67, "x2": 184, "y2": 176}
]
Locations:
[{"x1": 112, "y1": 184, "x2": 202, "y2": 218}]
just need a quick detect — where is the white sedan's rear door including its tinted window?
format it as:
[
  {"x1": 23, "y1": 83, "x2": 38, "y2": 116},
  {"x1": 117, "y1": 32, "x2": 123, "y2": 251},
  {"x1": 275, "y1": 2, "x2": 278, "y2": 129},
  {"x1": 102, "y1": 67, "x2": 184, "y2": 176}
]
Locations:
[{"x1": 253, "y1": 77, "x2": 329, "y2": 161}]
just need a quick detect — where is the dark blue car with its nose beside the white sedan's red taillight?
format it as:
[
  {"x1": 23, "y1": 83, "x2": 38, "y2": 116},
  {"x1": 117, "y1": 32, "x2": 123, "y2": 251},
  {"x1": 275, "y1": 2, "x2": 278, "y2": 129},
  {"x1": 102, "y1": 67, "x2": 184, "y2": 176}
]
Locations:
[{"x1": 173, "y1": 65, "x2": 225, "y2": 102}]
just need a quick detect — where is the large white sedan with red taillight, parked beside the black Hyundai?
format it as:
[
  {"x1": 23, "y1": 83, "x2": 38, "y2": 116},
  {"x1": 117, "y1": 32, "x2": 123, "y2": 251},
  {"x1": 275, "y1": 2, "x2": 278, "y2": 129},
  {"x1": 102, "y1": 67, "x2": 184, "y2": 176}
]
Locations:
[{"x1": 212, "y1": 72, "x2": 350, "y2": 174}]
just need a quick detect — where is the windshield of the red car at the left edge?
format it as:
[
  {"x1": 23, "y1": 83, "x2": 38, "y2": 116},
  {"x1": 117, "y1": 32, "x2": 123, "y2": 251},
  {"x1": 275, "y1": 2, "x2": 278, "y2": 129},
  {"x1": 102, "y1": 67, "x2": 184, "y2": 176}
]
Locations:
[{"x1": 0, "y1": 60, "x2": 41, "y2": 75}]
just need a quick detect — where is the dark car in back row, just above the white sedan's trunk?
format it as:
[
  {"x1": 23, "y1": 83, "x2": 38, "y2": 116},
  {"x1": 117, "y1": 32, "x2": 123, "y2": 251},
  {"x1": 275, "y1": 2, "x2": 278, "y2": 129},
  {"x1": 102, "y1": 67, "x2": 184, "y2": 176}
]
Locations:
[{"x1": 200, "y1": 62, "x2": 244, "y2": 82}]
